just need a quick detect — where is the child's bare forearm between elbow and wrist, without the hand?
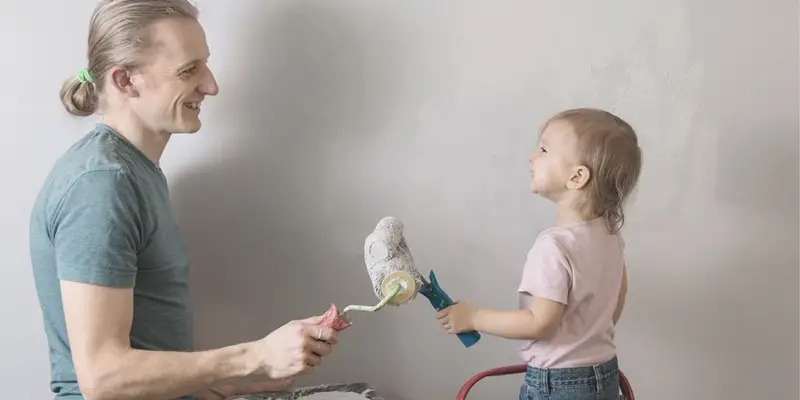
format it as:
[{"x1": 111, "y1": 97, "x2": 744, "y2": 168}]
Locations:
[{"x1": 474, "y1": 308, "x2": 548, "y2": 340}]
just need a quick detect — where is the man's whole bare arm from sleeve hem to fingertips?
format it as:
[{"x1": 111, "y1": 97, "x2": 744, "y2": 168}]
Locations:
[{"x1": 61, "y1": 281, "x2": 337, "y2": 400}]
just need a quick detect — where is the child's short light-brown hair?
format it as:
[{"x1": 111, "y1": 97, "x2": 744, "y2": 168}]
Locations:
[{"x1": 545, "y1": 108, "x2": 642, "y2": 233}]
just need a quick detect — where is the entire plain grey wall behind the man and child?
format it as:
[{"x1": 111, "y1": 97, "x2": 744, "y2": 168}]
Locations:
[{"x1": 0, "y1": 0, "x2": 800, "y2": 400}]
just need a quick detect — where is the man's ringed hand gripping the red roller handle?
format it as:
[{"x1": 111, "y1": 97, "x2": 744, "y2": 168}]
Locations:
[{"x1": 252, "y1": 316, "x2": 339, "y2": 380}]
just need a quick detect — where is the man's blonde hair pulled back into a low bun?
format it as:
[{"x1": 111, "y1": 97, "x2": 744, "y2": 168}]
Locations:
[{"x1": 59, "y1": 0, "x2": 198, "y2": 117}]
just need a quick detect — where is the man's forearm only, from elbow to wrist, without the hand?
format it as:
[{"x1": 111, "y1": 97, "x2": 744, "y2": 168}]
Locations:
[{"x1": 79, "y1": 343, "x2": 257, "y2": 400}]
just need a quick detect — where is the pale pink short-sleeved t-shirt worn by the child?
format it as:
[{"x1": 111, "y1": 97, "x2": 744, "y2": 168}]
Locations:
[{"x1": 518, "y1": 218, "x2": 624, "y2": 368}]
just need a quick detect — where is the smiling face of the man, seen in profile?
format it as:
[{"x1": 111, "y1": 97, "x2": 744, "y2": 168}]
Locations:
[{"x1": 131, "y1": 18, "x2": 219, "y2": 133}]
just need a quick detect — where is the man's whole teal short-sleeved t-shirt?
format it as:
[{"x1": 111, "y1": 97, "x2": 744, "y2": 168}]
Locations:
[{"x1": 30, "y1": 124, "x2": 193, "y2": 399}]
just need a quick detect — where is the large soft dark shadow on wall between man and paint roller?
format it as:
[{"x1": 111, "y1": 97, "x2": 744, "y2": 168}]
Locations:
[{"x1": 172, "y1": 2, "x2": 412, "y2": 394}]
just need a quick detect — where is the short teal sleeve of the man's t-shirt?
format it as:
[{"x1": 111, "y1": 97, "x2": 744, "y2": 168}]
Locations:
[{"x1": 51, "y1": 170, "x2": 141, "y2": 288}]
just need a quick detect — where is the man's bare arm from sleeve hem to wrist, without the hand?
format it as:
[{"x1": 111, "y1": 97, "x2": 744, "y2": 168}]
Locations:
[{"x1": 61, "y1": 281, "x2": 258, "y2": 400}]
